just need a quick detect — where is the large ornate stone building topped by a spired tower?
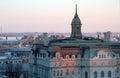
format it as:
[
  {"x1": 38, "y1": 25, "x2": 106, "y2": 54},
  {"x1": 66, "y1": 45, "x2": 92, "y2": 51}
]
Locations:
[{"x1": 29, "y1": 6, "x2": 120, "y2": 78}]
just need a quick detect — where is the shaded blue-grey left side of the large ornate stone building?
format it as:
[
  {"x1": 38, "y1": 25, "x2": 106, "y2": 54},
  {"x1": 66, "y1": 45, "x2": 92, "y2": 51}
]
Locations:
[{"x1": 29, "y1": 38, "x2": 50, "y2": 78}]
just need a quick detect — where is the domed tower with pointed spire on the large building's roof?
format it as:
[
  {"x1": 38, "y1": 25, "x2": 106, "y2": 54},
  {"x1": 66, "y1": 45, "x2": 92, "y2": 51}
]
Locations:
[{"x1": 71, "y1": 5, "x2": 82, "y2": 39}]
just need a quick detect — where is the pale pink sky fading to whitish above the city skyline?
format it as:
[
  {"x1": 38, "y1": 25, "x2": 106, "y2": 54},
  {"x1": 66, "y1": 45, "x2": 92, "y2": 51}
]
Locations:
[{"x1": 0, "y1": 0, "x2": 120, "y2": 33}]
